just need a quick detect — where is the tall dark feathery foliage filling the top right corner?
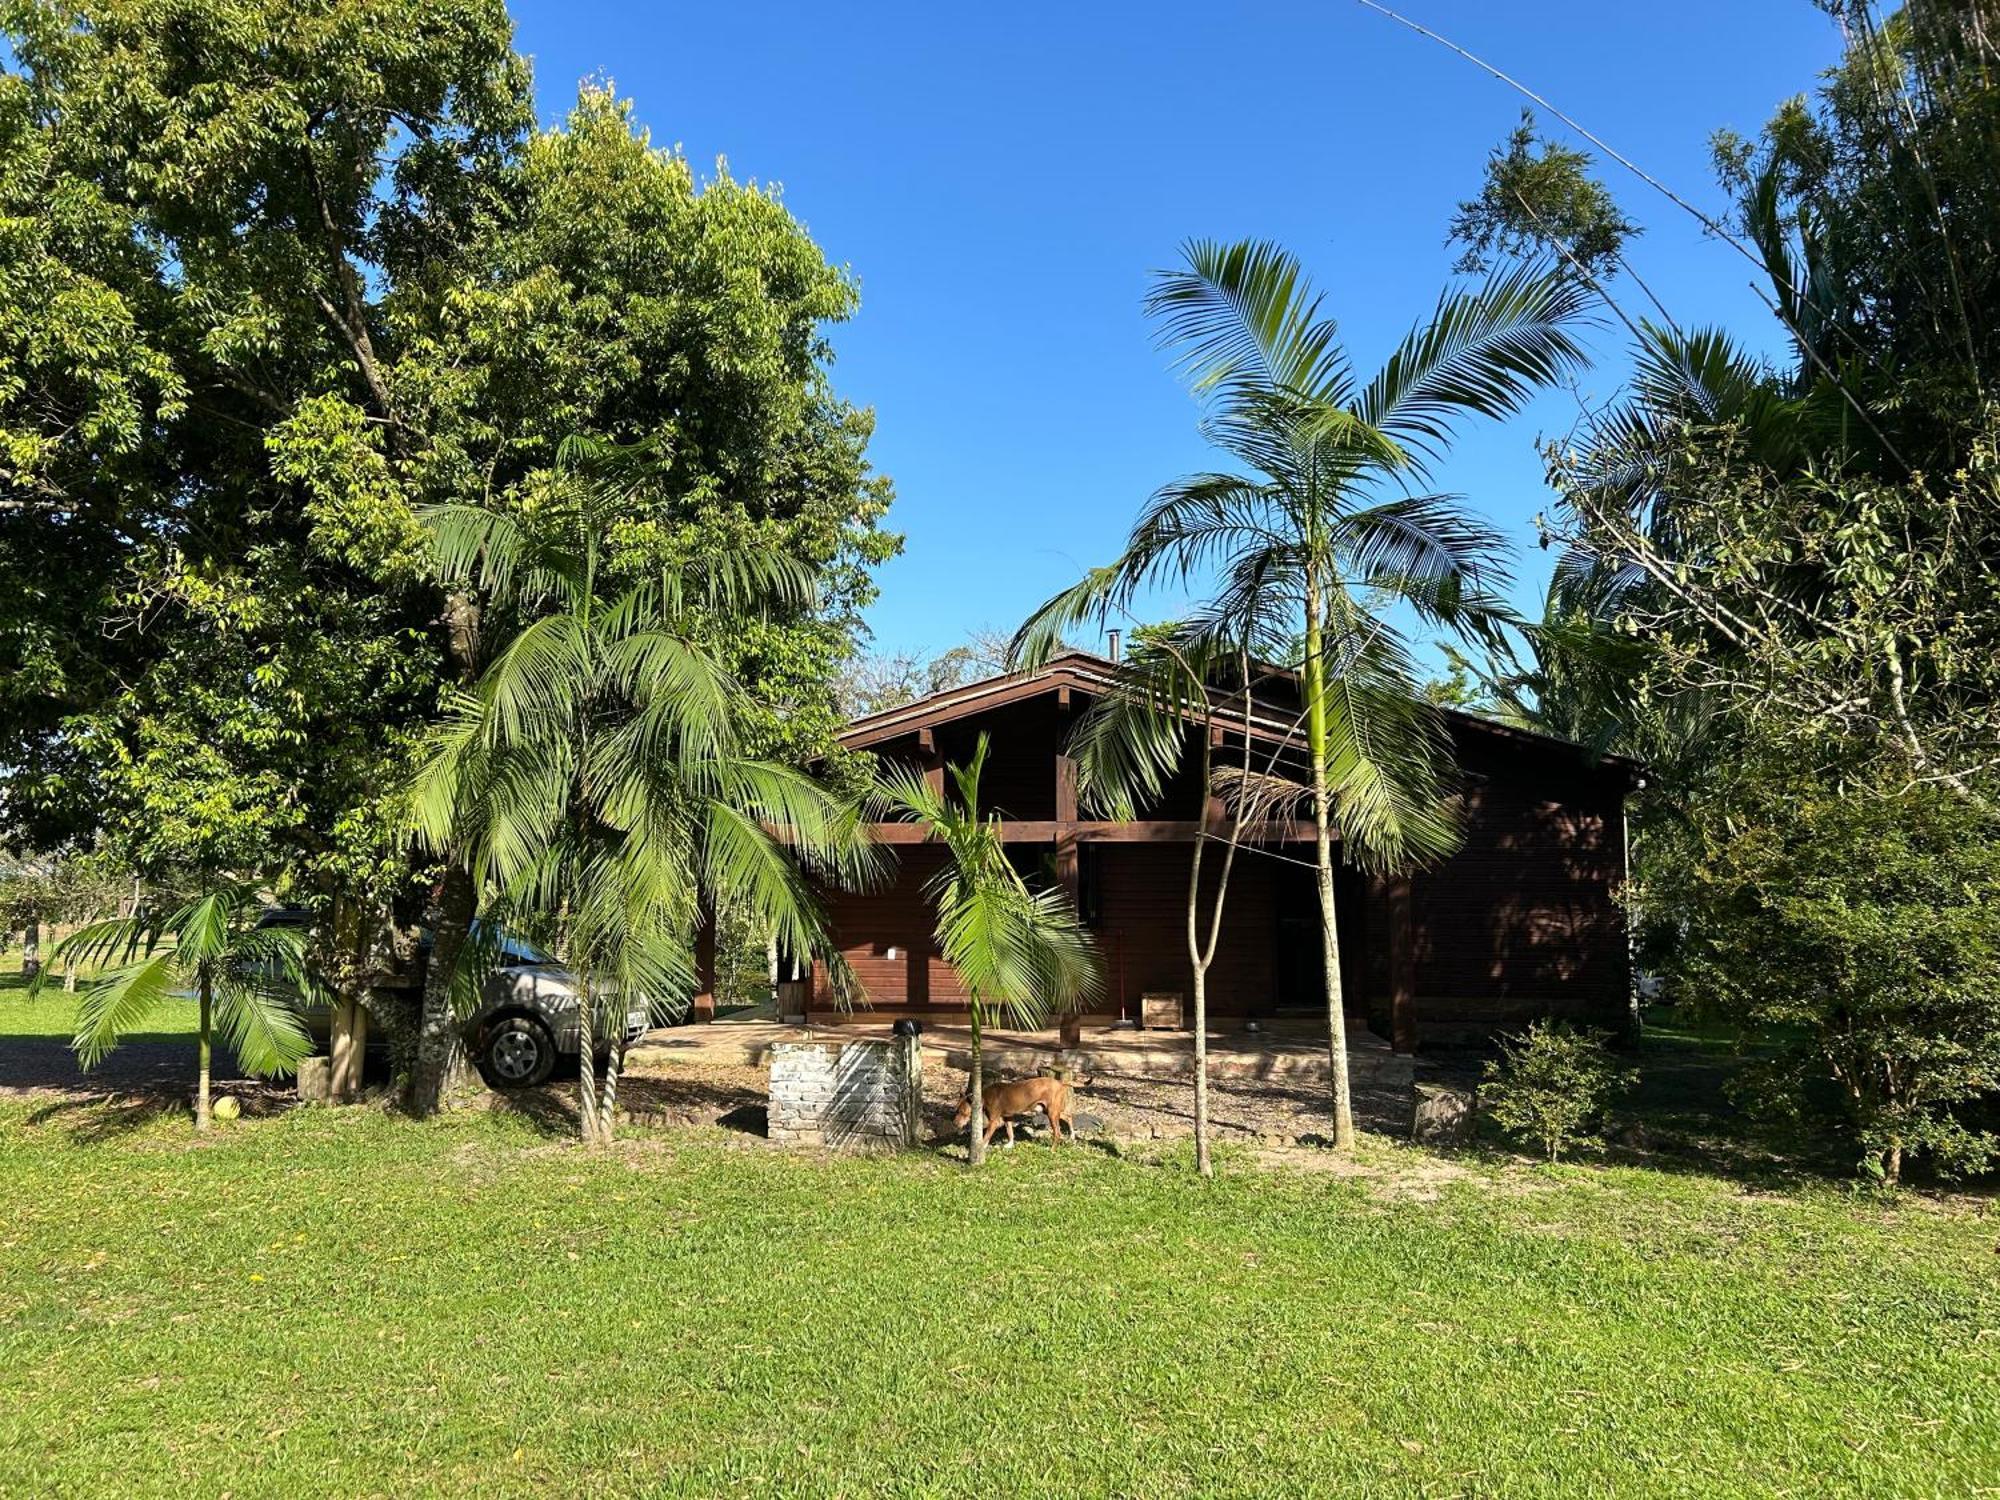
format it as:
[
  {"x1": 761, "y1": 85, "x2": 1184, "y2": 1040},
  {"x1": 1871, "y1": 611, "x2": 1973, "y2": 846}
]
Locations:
[{"x1": 1716, "y1": 0, "x2": 2000, "y2": 450}]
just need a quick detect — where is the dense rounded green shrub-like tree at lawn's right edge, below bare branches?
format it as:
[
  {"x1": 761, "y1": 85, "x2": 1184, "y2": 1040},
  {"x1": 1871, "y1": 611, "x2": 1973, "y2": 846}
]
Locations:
[{"x1": 1640, "y1": 752, "x2": 2000, "y2": 1182}]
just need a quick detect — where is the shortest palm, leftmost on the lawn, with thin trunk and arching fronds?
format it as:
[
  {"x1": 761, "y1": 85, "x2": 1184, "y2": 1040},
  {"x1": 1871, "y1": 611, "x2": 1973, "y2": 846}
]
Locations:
[{"x1": 42, "y1": 884, "x2": 312, "y2": 1130}]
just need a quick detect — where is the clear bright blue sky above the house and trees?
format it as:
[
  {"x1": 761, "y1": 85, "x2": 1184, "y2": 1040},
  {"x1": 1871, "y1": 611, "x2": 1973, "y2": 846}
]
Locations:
[{"x1": 514, "y1": 0, "x2": 1836, "y2": 650}]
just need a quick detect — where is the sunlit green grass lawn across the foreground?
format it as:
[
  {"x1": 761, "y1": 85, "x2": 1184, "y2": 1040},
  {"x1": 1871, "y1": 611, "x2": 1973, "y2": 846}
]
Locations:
[{"x1": 0, "y1": 996, "x2": 2000, "y2": 1500}]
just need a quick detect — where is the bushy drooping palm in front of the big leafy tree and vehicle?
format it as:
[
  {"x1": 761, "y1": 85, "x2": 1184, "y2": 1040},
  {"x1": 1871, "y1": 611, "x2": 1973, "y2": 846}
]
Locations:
[{"x1": 410, "y1": 438, "x2": 870, "y2": 1142}]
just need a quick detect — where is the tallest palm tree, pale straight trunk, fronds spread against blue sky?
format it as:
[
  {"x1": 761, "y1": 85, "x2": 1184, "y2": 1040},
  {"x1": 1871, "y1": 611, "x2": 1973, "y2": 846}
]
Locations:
[{"x1": 1016, "y1": 240, "x2": 1588, "y2": 1146}]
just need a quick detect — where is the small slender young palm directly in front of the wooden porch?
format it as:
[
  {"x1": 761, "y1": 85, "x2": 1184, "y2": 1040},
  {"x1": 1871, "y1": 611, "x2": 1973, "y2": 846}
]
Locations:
[{"x1": 876, "y1": 734, "x2": 1100, "y2": 1166}]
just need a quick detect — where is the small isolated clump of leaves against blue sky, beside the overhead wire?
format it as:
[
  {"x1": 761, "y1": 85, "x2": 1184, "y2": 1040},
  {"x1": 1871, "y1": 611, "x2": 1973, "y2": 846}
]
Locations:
[{"x1": 1448, "y1": 110, "x2": 1642, "y2": 282}]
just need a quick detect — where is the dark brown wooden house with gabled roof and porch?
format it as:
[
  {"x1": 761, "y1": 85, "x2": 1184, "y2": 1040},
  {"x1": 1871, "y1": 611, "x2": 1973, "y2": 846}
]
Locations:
[{"x1": 806, "y1": 652, "x2": 1632, "y2": 1050}]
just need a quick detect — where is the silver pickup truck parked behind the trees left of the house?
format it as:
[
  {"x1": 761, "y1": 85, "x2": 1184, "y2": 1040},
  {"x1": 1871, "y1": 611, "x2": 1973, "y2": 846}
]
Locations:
[{"x1": 258, "y1": 908, "x2": 652, "y2": 1090}]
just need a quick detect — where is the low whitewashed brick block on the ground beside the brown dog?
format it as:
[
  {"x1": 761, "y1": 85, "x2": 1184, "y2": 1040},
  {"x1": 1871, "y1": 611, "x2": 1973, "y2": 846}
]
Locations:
[{"x1": 770, "y1": 1036, "x2": 924, "y2": 1150}]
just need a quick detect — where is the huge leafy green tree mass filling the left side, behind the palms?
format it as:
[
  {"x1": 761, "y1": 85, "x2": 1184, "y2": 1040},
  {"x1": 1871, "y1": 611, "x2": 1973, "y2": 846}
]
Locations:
[{"x1": 0, "y1": 0, "x2": 898, "y2": 1104}]
